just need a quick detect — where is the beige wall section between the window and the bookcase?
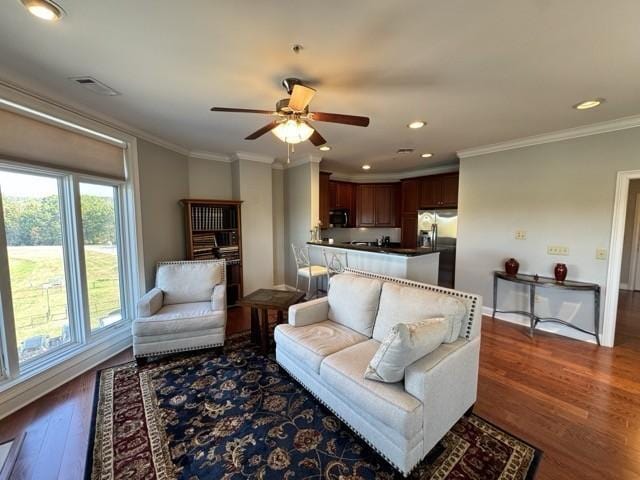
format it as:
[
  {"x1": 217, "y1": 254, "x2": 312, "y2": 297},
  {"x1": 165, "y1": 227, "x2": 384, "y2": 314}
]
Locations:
[{"x1": 138, "y1": 139, "x2": 189, "y2": 290}]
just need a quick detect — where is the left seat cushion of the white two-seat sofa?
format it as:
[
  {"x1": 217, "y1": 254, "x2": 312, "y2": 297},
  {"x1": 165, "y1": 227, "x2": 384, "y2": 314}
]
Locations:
[{"x1": 274, "y1": 320, "x2": 368, "y2": 373}]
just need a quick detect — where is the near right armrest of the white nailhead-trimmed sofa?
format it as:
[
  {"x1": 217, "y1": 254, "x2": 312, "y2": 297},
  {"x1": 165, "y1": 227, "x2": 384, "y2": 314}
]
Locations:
[{"x1": 404, "y1": 337, "x2": 480, "y2": 452}]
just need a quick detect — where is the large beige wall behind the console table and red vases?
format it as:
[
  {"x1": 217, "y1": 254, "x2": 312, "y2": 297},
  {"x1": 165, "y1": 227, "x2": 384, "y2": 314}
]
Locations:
[{"x1": 456, "y1": 129, "x2": 640, "y2": 338}]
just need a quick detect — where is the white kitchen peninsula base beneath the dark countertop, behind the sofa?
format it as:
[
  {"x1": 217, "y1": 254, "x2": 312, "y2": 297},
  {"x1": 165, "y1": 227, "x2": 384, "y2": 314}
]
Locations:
[{"x1": 307, "y1": 242, "x2": 440, "y2": 285}]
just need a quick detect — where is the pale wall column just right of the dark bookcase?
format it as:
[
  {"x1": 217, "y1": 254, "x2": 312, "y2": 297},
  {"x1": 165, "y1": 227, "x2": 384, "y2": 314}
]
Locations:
[{"x1": 231, "y1": 159, "x2": 274, "y2": 295}]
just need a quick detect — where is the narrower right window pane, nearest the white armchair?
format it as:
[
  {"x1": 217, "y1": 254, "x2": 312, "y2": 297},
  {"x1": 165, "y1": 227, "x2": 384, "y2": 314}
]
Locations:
[{"x1": 80, "y1": 182, "x2": 122, "y2": 331}]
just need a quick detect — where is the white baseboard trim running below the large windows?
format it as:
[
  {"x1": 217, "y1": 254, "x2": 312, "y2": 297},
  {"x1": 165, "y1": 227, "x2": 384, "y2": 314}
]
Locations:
[{"x1": 0, "y1": 326, "x2": 132, "y2": 419}]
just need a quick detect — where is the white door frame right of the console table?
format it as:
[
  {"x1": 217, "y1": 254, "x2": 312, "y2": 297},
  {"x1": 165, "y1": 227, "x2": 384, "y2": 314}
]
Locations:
[{"x1": 602, "y1": 170, "x2": 640, "y2": 347}]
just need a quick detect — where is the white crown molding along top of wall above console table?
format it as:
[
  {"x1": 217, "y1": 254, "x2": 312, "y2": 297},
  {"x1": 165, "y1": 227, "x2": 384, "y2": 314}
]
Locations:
[{"x1": 456, "y1": 115, "x2": 640, "y2": 158}]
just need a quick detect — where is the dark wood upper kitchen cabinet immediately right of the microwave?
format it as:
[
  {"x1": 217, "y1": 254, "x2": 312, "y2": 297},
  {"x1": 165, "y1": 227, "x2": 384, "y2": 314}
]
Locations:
[{"x1": 356, "y1": 183, "x2": 399, "y2": 227}]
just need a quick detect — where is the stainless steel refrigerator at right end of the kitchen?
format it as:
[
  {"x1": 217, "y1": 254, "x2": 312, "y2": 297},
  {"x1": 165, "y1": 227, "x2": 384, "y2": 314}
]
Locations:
[{"x1": 418, "y1": 209, "x2": 458, "y2": 288}]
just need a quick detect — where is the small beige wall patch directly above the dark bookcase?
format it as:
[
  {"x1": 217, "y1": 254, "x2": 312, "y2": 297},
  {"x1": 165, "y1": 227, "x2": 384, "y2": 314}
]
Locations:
[{"x1": 189, "y1": 157, "x2": 232, "y2": 200}]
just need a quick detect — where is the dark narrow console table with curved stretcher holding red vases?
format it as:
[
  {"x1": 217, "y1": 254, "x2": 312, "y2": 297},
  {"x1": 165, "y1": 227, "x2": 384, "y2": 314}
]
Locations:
[{"x1": 493, "y1": 270, "x2": 600, "y2": 345}]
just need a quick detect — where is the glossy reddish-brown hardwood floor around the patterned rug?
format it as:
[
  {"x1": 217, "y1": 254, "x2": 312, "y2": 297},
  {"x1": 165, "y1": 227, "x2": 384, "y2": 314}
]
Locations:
[{"x1": 0, "y1": 304, "x2": 640, "y2": 480}]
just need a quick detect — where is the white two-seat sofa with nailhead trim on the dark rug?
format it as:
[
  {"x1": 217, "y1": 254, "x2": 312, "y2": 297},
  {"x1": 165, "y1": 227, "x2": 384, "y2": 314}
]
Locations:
[{"x1": 275, "y1": 269, "x2": 482, "y2": 475}]
